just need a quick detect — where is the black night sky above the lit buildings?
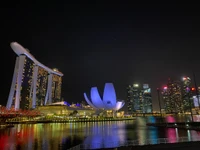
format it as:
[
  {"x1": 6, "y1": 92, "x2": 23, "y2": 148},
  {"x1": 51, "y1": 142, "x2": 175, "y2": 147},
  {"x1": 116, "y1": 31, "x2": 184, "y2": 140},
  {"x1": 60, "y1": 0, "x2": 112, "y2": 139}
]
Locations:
[{"x1": 0, "y1": 1, "x2": 200, "y2": 109}]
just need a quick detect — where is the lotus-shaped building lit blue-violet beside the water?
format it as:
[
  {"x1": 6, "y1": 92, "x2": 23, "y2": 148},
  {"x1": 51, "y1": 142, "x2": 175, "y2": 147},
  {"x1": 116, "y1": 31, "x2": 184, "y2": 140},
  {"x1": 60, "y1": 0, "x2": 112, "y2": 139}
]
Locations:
[{"x1": 84, "y1": 83, "x2": 125, "y2": 111}]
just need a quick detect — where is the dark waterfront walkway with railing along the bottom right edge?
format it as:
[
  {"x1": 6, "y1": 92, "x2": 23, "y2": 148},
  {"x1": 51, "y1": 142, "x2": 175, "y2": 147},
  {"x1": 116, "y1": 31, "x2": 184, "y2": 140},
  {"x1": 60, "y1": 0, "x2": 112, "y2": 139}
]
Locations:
[{"x1": 68, "y1": 137, "x2": 200, "y2": 150}]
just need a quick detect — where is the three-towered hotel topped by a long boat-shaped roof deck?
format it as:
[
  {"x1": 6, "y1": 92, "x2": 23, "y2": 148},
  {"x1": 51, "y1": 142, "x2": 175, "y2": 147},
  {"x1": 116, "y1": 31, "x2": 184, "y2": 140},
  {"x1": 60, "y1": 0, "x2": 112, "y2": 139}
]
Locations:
[{"x1": 6, "y1": 42, "x2": 63, "y2": 110}]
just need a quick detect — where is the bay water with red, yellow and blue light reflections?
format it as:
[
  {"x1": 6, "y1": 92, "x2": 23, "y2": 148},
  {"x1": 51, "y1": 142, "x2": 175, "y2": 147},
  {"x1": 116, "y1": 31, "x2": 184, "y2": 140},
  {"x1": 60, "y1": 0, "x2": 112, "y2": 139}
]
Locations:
[{"x1": 0, "y1": 117, "x2": 200, "y2": 150}]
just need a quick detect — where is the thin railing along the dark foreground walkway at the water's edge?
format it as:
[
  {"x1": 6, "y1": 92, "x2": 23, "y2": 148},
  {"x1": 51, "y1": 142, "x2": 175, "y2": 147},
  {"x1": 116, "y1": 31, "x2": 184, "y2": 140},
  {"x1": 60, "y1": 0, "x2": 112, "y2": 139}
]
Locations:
[{"x1": 68, "y1": 136, "x2": 200, "y2": 150}]
